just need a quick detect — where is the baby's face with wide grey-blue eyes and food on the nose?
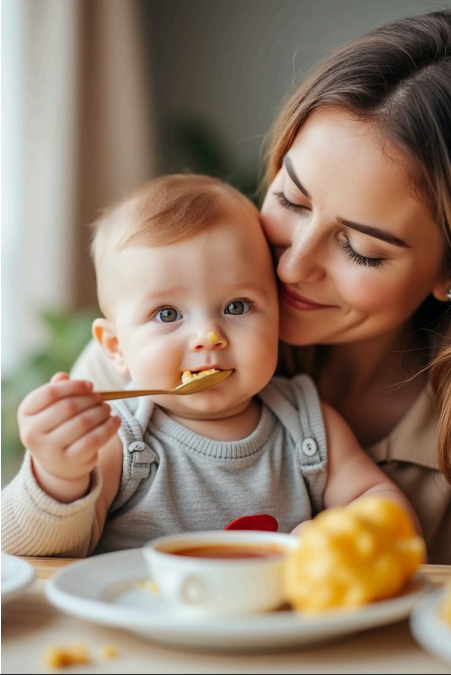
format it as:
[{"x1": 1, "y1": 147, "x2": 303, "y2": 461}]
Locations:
[{"x1": 104, "y1": 212, "x2": 278, "y2": 419}]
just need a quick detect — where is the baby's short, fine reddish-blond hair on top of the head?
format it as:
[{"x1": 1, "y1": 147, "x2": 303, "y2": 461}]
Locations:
[{"x1": 91, "y1": 173, "x2": 259, "y2": 266}]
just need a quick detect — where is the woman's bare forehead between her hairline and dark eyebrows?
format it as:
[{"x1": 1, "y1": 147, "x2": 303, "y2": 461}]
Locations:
[{"x1": 281, "y1": 108, "x2": 435, "y2": 238}]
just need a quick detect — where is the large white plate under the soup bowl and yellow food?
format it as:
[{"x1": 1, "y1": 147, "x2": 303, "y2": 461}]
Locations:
[{"x1": 45, "y1": 549, "x2": 429, "y2": 651}]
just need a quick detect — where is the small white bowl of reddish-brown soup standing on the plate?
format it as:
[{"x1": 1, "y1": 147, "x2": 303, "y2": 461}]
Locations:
[{"x1": 143, "y1": 530, "x2": 299, "y2": 617}]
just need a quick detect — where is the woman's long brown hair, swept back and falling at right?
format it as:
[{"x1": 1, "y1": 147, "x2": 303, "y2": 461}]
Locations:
[{"x1": 266, "y1": 10, "x2": 451, "y2": 482}]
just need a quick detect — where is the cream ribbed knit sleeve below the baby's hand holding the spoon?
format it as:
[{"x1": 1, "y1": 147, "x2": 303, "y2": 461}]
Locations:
[{"x1": 2, "y1": 453, "x2": 102, "y2": 558}]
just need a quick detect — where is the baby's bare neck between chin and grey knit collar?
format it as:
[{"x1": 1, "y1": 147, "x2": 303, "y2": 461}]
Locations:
[{"x1": 165, "y1": 398, "x2": 261, "y2": 442}]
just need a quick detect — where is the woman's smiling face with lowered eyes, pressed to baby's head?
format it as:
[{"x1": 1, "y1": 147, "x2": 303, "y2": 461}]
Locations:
[{"x1": 262, "y1": 108, "x2": 451, "y2": 345}]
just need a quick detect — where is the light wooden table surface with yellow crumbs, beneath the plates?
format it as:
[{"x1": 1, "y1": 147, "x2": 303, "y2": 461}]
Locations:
[{"x1": 1, "y1": 558, "x2": 451, "y2": 674}]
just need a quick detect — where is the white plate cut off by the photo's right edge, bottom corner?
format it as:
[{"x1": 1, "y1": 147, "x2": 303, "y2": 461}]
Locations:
[{"x1": 410, "y1": 588, "x2": 451, "y2": 664}]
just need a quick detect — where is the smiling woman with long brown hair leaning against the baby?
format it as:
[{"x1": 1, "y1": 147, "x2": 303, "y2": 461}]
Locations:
[{"x1": 72, "y1": 10, "x2": 451, "y2": 563}]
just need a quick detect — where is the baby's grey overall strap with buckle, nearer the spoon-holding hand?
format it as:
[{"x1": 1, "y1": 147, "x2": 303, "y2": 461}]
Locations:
[{"x1": 110, "y1": 396, "x2": 158, "y2": 512}]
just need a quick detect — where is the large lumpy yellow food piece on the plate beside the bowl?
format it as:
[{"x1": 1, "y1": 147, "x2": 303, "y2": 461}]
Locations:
[{"x1": 284, "y1": 495, "x2": 425, "y2": 613}]
